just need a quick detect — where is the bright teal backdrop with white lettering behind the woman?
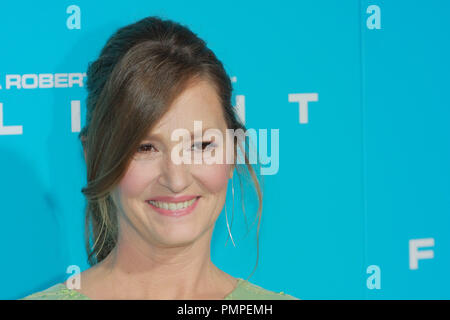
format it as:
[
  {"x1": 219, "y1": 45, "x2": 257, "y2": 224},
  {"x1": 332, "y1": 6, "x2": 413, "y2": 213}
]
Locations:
[{"x1": 0, "y1": 0, "x2": 450, "y2": 299}]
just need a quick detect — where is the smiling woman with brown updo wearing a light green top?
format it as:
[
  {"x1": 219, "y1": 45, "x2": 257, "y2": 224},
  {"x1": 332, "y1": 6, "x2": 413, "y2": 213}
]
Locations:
[{"x1": 21, "y1": 17, "x2": 296, "y2": 299}]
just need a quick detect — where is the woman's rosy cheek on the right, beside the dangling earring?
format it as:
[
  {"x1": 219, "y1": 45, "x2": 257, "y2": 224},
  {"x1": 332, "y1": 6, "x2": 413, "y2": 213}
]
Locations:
[{"x1": 195, "y1": 164, "x2": 230, "y2": 193}]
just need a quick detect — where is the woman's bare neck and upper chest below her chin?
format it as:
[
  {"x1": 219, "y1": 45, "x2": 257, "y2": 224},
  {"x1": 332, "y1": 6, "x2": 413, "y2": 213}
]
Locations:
[{"x1": 92, "y1": 221, "x2": 235, "y2": 300}]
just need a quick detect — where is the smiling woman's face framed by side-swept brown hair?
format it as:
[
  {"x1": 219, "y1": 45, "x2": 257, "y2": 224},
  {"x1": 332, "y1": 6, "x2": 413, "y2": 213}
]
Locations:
[{"x1": 114, "y1": 81, "x2": 233, "y2": 247}]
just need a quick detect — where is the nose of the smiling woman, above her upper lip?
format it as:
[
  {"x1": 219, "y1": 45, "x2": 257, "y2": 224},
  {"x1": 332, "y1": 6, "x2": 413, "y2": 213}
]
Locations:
[{"x1": 158, "y1": 155, "x2": 192, "y2": 193}]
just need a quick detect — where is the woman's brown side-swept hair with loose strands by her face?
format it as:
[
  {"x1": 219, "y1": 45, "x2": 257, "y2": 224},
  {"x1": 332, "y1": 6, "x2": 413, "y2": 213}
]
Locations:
[{"x1": 79, "y1": 17, "x2": 262, "y2": 278}]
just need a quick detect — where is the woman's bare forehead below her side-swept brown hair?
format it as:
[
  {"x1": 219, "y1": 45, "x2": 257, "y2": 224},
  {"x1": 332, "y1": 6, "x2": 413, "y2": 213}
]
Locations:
[{"x1": 147, "y1": 80, "x2": 226, "y2": 139}]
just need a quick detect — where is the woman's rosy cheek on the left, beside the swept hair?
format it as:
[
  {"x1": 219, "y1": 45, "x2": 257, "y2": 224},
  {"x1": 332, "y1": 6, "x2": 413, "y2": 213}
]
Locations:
[{"x1": 119, "y1": 163, "x2": 155, "y2": 198}]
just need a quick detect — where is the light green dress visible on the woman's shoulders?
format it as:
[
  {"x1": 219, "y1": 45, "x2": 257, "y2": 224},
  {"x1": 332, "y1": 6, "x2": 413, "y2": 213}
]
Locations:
[{"x1": 19, "y1": 278, "x2": 299, "y2": 300}]
